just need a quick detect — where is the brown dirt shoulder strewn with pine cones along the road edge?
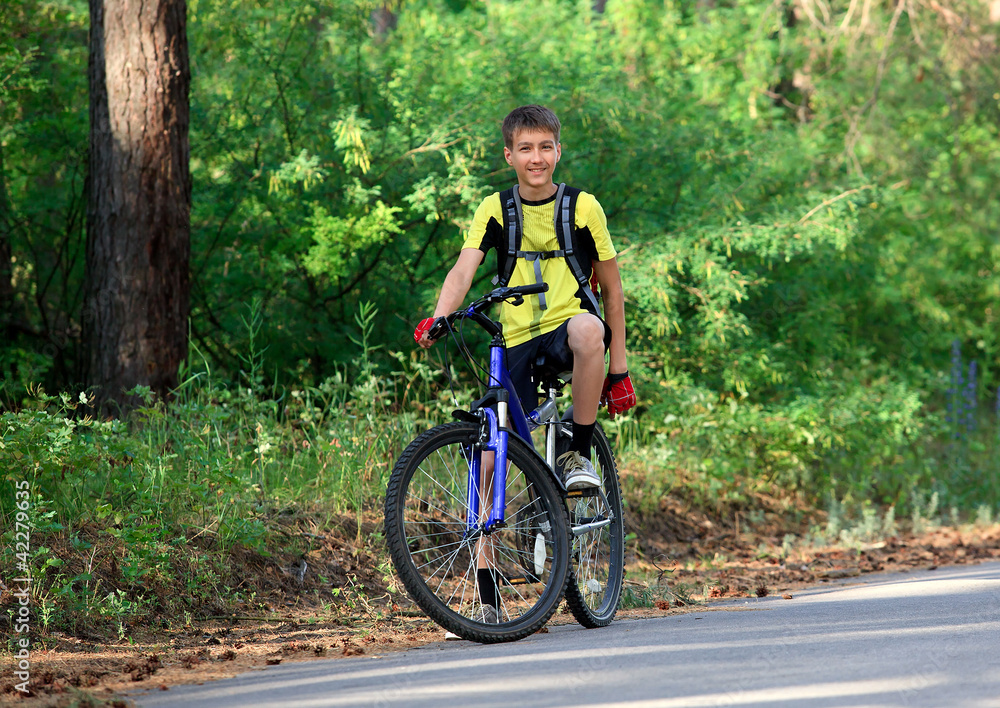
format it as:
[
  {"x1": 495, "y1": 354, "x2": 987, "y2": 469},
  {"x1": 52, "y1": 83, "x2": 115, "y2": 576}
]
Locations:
[{"x1": 7, "y1": 526, "x2": 1000, "y2": 708}]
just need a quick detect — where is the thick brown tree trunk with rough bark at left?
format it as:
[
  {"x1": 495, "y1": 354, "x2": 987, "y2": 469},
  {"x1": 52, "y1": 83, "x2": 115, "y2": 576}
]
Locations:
[{"x1": 83, "y1": 0, "x2": 191, "y2": 412}]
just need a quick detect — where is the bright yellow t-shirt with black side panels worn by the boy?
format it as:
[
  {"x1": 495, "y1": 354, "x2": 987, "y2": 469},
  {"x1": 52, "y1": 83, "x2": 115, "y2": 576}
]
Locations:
[{"x1": 462, "y1": 192, "x2": 618, "y2": 347}]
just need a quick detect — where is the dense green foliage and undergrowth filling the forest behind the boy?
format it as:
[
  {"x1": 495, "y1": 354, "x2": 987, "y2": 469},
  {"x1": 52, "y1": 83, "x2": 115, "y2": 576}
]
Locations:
[{"x1": 0, "y1": 0, "x2": 1000, "y2": 556}]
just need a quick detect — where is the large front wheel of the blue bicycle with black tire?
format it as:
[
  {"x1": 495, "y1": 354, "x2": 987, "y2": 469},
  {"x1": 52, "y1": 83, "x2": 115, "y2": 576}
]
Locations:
[{"x1": 385, "y1": 423, "x2": 569, "y2": 643}]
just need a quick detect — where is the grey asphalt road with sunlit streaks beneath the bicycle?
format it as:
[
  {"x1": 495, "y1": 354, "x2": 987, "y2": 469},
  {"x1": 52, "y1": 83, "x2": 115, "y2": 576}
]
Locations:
[{"x1": 131, "y1": 563, "x2": 1000, "y2": 708}]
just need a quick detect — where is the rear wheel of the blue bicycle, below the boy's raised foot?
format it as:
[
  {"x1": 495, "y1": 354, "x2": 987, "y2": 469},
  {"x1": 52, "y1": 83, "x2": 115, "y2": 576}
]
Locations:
[{"x1": 556, "y1": 422, "x2": 625, "y2": 628}]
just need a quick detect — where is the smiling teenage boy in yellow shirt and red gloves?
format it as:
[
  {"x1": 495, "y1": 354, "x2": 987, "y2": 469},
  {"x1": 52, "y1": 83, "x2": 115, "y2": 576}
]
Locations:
[{"x1": 413, "y1": 105, "x2": 635, "y2": 489}]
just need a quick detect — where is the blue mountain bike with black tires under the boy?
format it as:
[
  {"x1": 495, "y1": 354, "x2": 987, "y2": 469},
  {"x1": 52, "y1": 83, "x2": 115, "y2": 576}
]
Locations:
[{"x1": 384, "y1": 283, "x2": 625, "y2": 643}]
